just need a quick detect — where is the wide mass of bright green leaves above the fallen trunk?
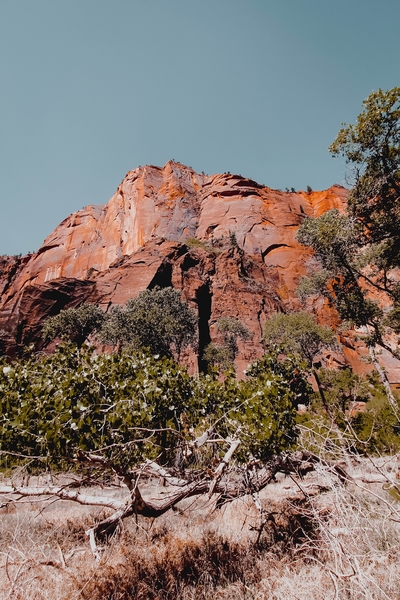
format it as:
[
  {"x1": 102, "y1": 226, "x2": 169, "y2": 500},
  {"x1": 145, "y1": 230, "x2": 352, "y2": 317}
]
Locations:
[{"x1": 0, "y1": 342, "x2": 305, "y2": 464}]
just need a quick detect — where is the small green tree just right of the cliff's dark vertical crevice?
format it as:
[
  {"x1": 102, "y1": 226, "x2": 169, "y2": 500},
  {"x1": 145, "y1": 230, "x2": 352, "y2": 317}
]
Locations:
[{"x1": 203, "y1": 317, "x2": 253, "y2": 369}]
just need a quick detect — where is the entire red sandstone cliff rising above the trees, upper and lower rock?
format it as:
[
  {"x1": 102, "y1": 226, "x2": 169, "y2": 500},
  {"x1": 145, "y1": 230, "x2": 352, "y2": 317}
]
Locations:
[{"x1": 0, "y1": 162, "x2": 386, "y2": 376}]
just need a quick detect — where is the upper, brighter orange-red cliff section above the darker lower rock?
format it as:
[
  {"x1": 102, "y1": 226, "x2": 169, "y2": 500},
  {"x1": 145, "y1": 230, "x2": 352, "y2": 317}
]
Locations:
[{"x1": 3, "y1": 162, "x2": 346, "y2": 288}]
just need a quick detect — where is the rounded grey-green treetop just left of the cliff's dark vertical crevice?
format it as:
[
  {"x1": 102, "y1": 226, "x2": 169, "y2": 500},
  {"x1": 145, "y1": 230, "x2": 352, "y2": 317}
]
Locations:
[{"x1": 100, "y1": 287, "x2": 197, "y2": 359}]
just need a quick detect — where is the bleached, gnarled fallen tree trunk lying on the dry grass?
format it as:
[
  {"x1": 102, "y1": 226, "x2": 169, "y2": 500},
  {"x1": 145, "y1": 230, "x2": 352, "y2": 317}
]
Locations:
[{"x1": 0, "y1": 450, "x2": 340, "y2": 553}]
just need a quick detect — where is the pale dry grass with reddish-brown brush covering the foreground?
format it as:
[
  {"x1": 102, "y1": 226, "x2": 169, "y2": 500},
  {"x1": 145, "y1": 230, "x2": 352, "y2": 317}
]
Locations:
[{"x1": 0, "y1": 460, "x2": 400, "y2": 600}]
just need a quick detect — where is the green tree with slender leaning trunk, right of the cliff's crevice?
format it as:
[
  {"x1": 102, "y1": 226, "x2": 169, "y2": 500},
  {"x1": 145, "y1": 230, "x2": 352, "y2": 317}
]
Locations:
[{"x1": 264, "y1": 312, "x2": 339, "y2": 407}]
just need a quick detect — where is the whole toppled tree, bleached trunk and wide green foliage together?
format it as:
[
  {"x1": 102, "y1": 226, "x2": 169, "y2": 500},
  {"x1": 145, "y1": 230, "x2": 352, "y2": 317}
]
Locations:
[{"x1": 0, "y1": 343, "x2": 316, "y2": 540}]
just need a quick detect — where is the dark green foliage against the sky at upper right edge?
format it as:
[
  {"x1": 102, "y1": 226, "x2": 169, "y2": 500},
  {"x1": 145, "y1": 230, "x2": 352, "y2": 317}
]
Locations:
[{"x1": 330, "y1": 87, "x2": 400, "y2": 258}]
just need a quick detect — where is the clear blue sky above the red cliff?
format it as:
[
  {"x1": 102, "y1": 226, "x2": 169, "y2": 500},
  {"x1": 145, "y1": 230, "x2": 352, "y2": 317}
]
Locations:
[{"x1": 0, "y1": 0, "x2": 400, "y2": 254}]
